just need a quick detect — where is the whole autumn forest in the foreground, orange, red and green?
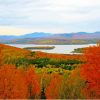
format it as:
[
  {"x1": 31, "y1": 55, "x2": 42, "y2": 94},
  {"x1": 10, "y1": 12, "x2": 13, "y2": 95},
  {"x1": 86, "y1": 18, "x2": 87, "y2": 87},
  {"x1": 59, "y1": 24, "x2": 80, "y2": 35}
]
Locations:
[{"x1": 0, "y1": 44, "x2": 100, "y2": 99}]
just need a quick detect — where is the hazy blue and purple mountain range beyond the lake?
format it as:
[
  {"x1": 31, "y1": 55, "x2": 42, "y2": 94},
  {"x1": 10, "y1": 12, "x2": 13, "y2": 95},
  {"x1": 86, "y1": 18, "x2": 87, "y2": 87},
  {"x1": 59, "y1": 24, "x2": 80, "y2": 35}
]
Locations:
[{"x1": 0, "y1": 32, "x2": 100, "y2": 44}]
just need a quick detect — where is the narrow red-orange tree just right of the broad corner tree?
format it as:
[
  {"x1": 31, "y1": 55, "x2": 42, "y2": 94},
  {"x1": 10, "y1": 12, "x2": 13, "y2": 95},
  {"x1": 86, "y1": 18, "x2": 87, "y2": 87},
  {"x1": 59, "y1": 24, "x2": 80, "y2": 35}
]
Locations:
[{"x1": 26, "y1": 66, "x2": 41, "y2": 98}]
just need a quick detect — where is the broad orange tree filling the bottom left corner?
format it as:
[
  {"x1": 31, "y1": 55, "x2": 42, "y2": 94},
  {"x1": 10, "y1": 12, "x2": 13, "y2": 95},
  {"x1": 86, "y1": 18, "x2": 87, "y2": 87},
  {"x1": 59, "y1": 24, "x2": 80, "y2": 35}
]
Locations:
[{"x1": 0, "y1": 65, "x2": 28, "y2": 99}]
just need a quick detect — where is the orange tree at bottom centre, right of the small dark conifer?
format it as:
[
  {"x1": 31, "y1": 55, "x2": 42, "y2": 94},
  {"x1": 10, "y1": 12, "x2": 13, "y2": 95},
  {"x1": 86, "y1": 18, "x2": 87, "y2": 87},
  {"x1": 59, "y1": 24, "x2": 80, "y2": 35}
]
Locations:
[{"x1": 46, "y1": 74, "x2": 63, "y2": 99}]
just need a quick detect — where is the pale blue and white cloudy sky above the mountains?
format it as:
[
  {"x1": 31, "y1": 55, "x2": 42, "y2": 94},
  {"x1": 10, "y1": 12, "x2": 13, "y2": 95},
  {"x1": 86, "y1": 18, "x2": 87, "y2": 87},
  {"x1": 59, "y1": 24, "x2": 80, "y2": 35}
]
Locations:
[{"x1": 0, "y1": 0, "x2": 100, "y2": 35}]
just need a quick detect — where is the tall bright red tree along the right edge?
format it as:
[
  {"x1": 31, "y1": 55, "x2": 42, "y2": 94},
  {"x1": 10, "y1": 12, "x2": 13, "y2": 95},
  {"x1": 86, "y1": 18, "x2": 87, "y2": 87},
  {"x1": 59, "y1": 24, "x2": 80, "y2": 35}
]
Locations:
[{"x1": 81, "y1": 46, "x2": 100, "y2": 99}]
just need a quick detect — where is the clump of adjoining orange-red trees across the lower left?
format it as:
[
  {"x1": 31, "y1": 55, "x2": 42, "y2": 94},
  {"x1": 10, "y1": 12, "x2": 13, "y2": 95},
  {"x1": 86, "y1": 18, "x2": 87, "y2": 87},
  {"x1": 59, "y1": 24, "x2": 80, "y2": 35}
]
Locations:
[{"x1": 0, "y1": 65, "x2": 40, "y2": 99}]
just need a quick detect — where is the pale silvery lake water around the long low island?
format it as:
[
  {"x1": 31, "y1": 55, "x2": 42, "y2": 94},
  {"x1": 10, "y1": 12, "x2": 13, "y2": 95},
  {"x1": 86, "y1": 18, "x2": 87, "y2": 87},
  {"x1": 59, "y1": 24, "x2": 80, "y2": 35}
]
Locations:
[{"x1": 9, "y1": 44, "x2": 96, "y2": 54}]
